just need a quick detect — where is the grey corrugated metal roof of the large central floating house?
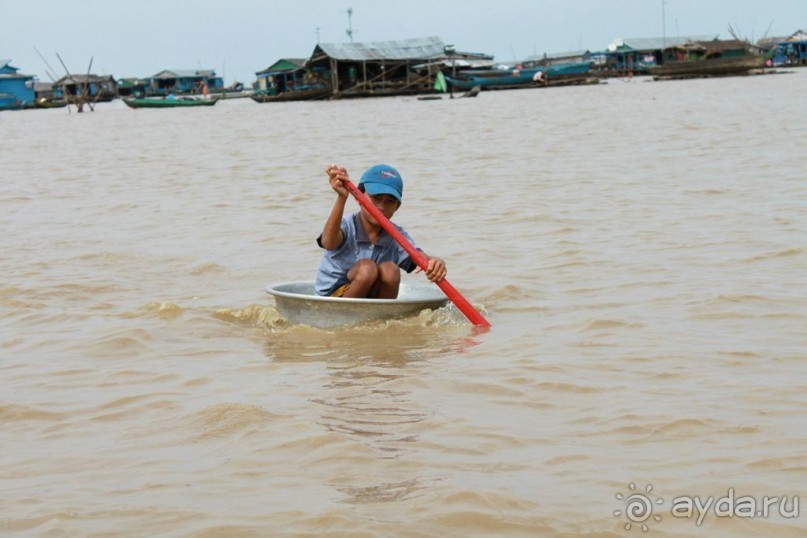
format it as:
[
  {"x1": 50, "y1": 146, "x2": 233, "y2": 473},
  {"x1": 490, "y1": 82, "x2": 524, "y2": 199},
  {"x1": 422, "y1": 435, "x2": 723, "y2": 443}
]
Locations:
[{"x1": 317, "y1": 37, "x2": 445, "y2": 61}]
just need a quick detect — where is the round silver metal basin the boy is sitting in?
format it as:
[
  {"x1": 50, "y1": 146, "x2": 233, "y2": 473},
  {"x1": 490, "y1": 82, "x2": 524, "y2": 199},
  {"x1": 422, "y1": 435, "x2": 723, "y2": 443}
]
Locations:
[{"x1": 266, "y1": 282, "x2": 448, "y2": 329}]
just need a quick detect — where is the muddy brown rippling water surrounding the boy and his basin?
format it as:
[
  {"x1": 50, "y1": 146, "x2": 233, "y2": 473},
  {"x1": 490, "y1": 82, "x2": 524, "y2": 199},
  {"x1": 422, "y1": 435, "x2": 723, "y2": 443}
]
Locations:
[{"x1": 0, "y1": 70, "x2": 807, "y2": 537}]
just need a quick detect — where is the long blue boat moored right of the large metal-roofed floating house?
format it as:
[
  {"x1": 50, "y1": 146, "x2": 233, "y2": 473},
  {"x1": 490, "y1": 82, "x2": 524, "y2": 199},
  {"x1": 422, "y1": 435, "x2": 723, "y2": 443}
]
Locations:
[{"x1": 445, "y1": 62, "x2": 591, "y2": 90}]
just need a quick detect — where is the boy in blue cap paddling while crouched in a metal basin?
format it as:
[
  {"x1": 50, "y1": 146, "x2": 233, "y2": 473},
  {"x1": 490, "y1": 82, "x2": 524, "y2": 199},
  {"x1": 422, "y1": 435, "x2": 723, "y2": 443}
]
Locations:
[{"x1": 315, "y1": 164, "x2": 446, "y2": 299}]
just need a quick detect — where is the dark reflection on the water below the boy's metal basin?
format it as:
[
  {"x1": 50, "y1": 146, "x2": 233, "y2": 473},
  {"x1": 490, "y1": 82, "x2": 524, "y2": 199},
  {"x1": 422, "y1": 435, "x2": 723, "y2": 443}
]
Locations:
[{"x1": 264, "y1": 311, "x2": 480, "y2": 457}]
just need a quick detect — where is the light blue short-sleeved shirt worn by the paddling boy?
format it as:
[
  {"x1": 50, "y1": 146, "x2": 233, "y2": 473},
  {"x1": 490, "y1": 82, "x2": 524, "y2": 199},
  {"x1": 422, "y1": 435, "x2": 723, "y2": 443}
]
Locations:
[{"x1": 314, "y1": 212, "x2": 420, "y2": 296}]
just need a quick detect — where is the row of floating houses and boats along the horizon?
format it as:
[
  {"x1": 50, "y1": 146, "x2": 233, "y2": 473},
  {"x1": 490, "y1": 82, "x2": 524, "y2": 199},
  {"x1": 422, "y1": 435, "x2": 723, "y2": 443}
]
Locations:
[{"x1": 0, "y1": 27, "x2": 807, "y2": 112}]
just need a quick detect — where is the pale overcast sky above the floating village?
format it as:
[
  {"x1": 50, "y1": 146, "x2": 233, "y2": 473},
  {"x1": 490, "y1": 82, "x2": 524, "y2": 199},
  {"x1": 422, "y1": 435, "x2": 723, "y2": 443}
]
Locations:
[{"x1": 0, "y1": 0, "x2": 807, "y2": 84}]
